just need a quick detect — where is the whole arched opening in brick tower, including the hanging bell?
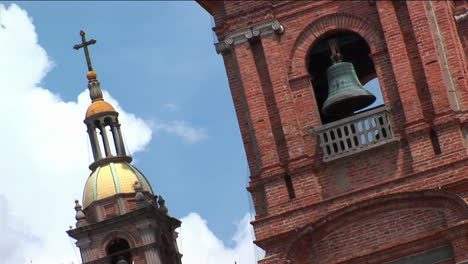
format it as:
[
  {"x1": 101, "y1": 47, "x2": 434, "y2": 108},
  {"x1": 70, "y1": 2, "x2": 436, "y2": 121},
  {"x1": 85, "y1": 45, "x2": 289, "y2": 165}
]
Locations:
[{"x1": 307, "y1": 31, "x2": 383, "y2": 124}]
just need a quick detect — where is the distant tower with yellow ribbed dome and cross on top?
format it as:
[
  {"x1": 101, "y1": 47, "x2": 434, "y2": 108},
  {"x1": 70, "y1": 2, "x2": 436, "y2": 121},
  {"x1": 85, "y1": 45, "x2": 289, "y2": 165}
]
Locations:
[{"x1": 67, "y1": 31, "x2": 182, "y2": 264}]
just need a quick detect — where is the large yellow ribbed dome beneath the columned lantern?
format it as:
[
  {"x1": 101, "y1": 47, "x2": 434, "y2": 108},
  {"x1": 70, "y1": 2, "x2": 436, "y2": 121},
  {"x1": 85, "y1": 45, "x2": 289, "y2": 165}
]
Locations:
[{"x1": 83, "y1": 162, "x2": 154, "y2": 208}]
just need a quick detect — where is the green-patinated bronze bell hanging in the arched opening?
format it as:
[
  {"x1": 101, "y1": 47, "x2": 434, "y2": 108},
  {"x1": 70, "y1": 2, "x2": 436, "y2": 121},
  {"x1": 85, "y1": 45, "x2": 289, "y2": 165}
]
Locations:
[{"x1": 322, "y1": 41, "x2": 376, "y2": 116}]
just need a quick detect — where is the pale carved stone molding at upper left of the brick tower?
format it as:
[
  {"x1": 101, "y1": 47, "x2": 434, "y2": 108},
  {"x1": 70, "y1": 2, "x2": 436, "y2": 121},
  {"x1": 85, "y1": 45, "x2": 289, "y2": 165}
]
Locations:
[{"x1": 215, "y1": 19, "x2": 284, "y2": 54}]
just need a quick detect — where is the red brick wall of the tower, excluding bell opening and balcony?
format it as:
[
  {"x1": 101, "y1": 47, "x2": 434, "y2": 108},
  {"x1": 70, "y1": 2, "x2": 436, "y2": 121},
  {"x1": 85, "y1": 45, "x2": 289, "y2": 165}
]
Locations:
[{"x1": 196, "y1": 0, "x2": 468, "y2": 264}]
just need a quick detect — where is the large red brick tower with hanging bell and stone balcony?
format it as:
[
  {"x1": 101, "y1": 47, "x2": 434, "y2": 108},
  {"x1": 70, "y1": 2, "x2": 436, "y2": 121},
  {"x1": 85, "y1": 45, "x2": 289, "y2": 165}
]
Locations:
[{"x1": 197, "y1": 0, "x2": 468, "y2": 264}]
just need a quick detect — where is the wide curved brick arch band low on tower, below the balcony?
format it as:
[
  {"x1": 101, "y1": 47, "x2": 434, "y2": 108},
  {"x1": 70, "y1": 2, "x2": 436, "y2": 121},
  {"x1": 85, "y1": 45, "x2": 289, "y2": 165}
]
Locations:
[{"x1": 280, "y1": 191, "x2": 468, "y2": 263}]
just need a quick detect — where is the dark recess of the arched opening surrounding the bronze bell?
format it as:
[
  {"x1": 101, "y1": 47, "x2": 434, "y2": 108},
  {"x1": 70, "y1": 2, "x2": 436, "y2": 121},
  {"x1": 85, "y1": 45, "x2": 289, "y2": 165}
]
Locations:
[{"x1": 307, "y1": 31, "x2": 383, "y2": 124}]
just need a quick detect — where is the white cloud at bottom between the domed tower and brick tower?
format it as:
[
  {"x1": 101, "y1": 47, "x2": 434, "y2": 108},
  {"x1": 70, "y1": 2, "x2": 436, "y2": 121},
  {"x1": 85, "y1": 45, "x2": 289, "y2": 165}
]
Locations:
[{"x1": 177, "y1": 213, "x2": 264, "y2": 264}]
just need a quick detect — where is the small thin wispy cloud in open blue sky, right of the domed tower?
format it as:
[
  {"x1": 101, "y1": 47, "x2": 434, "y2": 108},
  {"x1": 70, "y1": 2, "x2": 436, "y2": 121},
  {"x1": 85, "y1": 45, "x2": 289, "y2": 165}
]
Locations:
[{"x1": 152, "y1": 120, "x2": 208, "y2": 143}]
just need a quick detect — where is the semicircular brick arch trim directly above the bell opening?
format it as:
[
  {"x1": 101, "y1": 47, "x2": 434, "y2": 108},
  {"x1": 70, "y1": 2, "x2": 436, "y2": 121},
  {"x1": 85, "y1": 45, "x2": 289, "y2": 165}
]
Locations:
[{"x1": 288, "y1": 13, "x2": 385, "y2": 80}]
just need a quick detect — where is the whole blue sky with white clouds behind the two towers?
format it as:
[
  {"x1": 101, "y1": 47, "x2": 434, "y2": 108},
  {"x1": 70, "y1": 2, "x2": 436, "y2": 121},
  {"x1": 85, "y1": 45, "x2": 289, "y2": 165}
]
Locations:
[{"x1": 0, "y1": 1, "x2": 381, "y2": 264}]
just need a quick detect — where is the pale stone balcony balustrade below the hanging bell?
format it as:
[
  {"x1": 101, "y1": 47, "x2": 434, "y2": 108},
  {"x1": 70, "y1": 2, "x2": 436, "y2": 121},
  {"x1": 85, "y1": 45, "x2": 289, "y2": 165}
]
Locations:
[{"x1": 314, "y1": 105, "x2": 397, "y2": 162}]
